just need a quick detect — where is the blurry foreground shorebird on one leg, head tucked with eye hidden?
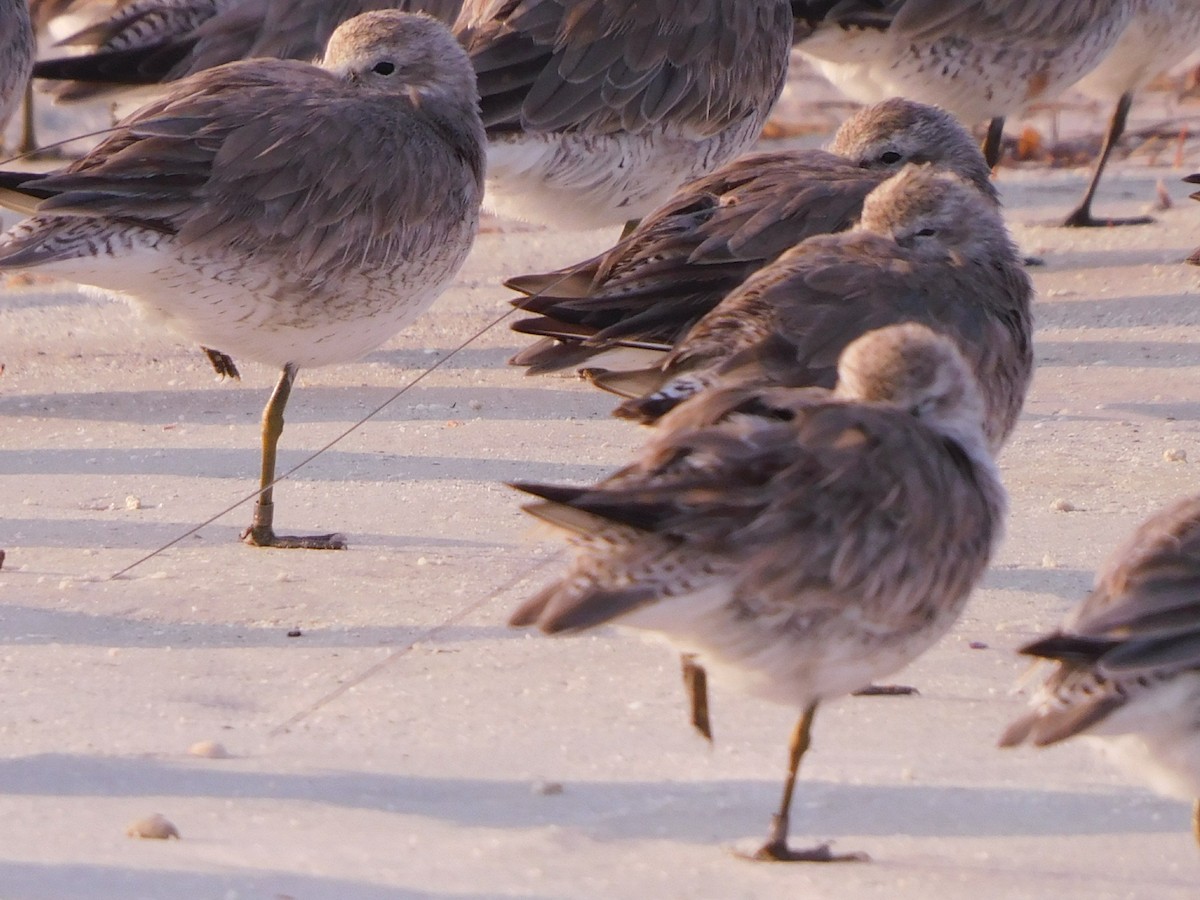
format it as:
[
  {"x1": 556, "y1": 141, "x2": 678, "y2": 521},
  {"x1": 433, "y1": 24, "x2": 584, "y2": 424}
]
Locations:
[{"x1": 510, "y1": 324, "x2": 1006, "y2": 862}]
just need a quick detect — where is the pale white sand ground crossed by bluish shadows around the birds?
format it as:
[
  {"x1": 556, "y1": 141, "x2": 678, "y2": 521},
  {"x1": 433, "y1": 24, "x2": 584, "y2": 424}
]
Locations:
[{"x1": 0, "y1": 103, "x2": 1200, "y2": 900}]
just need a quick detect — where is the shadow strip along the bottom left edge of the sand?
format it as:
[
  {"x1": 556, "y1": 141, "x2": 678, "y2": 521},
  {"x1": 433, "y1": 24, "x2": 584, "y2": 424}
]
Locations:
[{"x1": 0, "y1": 862, "x2": 506, "y2": 900}]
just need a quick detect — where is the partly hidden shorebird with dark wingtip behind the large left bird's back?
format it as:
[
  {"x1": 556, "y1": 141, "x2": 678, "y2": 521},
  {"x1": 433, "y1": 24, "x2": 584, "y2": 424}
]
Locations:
[{"x1": 34, "y1": 0, "x2": 461, "y2": 101}]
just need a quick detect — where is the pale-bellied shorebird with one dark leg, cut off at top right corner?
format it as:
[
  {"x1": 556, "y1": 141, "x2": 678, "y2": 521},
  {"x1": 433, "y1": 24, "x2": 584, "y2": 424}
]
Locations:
[{"x1": 1063, "y1": 0, "x2": 1200, "y2": 228}]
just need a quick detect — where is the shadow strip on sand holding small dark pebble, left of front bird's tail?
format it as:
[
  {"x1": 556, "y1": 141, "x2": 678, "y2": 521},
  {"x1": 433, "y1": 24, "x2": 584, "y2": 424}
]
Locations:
[{"x1": 0, "y1": 604, "x2": 524, "y2": 650}]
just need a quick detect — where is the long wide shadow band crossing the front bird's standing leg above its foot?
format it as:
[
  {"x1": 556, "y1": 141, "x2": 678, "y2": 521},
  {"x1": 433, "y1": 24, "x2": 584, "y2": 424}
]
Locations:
[{"x1": 0, "y1": 754, "x2": 1188, "y2": 844}]
